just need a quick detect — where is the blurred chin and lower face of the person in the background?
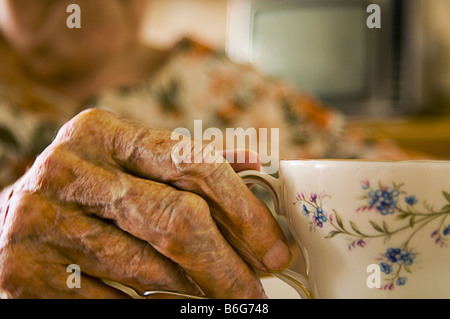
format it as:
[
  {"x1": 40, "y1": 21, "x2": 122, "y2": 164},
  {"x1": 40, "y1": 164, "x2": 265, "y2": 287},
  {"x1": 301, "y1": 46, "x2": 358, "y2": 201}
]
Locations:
[{"x1": 0, "y1": 0, "x2": 147, "y2": 79}]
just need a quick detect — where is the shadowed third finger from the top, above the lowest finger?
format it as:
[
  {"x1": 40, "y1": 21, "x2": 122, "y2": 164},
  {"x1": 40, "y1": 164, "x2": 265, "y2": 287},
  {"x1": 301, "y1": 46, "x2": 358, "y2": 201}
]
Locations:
[{"x1": 14, "y1": 195, "x2": 203, "y2": 297}]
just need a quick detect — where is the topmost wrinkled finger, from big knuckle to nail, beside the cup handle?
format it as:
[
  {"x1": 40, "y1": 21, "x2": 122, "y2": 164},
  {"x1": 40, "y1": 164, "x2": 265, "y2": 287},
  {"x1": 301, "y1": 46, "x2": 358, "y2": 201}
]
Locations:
[{"x1": 56, "y1": 110, "x2": 291, "y2": 271}]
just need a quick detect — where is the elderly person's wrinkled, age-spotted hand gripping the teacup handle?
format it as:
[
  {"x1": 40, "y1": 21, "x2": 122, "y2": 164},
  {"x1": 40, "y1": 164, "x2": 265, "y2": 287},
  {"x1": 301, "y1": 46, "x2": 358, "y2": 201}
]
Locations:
[{"x1": 0, "y1": 109, "x2": 291, "y2": 298}]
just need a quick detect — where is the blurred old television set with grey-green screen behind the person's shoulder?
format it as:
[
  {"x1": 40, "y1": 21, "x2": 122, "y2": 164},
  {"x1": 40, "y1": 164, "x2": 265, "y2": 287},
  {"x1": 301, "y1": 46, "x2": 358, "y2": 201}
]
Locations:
[{"x1": 227, "y1": 0, "x2": 423, "y2": 117}]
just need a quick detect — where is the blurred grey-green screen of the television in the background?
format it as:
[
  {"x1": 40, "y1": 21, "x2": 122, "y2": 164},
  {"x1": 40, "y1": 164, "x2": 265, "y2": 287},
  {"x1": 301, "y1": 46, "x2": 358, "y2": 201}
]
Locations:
[{"x1": 251, "y1": 5, "x2": 371, "y2": 101}]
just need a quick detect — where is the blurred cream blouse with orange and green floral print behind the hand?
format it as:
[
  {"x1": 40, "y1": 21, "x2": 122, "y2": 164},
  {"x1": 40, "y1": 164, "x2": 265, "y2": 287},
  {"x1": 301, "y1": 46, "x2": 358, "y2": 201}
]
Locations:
[{"x1": 0, "y1": 38, "x2": 386, "y2": 187}]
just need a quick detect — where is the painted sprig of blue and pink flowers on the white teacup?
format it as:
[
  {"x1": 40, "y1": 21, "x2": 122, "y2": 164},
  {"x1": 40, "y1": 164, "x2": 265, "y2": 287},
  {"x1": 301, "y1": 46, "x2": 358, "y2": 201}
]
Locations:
[{"x1": 293, "y1": 180, "x2": 450, "y2": 290}]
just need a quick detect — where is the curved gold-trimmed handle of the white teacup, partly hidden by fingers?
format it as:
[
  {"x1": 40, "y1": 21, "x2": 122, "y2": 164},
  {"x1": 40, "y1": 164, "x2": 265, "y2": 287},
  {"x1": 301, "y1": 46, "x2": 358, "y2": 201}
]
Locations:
[{"x1": 238, "y1": 170, "x2": 312, "y2": 299}]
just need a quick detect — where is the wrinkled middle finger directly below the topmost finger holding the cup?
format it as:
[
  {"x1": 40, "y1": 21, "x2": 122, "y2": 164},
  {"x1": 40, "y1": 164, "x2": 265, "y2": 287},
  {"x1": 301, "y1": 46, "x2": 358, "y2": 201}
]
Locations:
[{"x1": 30, "y1": 152, "x2": 265, "y2": 298}]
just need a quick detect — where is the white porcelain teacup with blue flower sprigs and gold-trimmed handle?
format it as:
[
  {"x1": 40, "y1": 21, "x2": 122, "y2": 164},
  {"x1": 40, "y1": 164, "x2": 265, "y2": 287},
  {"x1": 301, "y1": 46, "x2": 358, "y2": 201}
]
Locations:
[{"x1": 240, "y1": 160, "x2": 450, "y2": 298}]
